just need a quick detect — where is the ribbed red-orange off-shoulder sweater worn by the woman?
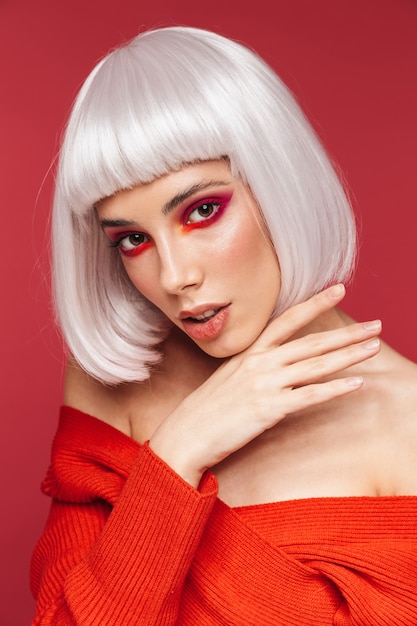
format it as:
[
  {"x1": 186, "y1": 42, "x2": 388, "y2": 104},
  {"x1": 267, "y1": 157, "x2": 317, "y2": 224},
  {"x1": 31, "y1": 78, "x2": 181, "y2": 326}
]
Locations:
[{"x1": 32, "y1": 407, "x2": 417, "y2": 626}]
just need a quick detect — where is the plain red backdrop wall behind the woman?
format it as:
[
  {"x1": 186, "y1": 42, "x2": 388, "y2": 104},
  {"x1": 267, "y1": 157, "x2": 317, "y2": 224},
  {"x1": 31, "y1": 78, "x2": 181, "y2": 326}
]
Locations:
[{"x1": 0, "y1": 0, "x2": 417, "y2": 626}]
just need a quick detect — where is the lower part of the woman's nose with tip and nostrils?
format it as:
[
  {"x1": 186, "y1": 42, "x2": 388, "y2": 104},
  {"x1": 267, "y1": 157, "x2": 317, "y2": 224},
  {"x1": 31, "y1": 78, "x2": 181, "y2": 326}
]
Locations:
[{"x1": 160, "y1": 242, "x2": 203, "y2": 294}]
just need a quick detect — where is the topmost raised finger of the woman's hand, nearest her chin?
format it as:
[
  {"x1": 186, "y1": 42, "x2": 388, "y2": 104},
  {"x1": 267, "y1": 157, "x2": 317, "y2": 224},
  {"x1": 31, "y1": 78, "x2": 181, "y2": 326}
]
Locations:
[{"x1": 254, "y1": 284, "x2": 346, "y2": 352}]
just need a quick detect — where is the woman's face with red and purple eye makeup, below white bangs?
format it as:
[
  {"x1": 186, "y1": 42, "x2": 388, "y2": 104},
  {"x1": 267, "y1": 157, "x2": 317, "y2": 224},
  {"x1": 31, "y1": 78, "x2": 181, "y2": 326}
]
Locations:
[{"x1": 97, "y1": 161, "x2": 280, "y2": 358}]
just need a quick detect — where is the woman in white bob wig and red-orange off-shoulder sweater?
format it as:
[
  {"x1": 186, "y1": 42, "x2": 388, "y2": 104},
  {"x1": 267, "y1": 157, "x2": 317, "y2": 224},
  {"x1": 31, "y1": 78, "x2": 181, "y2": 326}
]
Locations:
[{"x1": 32, "y1": 27, "x2": 417, "y2": 626}]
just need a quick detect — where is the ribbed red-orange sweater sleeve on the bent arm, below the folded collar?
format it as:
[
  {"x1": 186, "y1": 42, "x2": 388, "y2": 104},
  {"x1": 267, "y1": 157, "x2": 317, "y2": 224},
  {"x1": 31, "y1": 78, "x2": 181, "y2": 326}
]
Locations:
[{"x1": 32, "y1": 412, "x2": 217, "y2": 626}]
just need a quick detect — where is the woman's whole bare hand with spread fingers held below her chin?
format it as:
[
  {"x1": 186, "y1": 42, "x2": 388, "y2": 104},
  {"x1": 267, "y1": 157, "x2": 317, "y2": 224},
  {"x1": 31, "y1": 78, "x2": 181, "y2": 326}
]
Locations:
[{"x1": 149, "y1": 285, "x2": 381, "y2": 487}]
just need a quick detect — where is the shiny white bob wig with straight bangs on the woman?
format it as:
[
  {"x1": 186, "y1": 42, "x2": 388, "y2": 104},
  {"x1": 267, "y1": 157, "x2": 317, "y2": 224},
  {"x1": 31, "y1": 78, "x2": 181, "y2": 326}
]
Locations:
[{"x1": 52, "y1": 26, "x2": 356, "y2": 384}]
